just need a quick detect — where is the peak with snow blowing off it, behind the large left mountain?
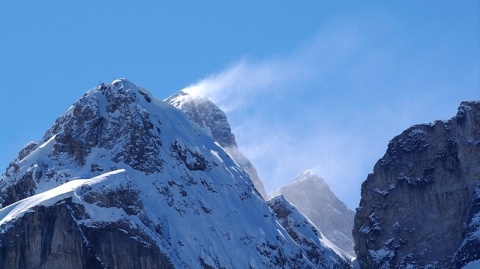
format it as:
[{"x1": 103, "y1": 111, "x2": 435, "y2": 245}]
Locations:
[{"x1": 165, "y1": 91, "x2": 268, "y2": 199}]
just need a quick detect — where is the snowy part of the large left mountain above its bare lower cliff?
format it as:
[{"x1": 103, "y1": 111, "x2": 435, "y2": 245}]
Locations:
[{"x1": 0, "y1": 79, "x2": 352, "y2": 268}]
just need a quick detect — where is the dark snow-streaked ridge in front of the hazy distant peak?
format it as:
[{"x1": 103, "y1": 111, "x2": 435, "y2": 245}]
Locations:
[{"x1": 268, "y1": 194, "x2": 352, "y2": 269}]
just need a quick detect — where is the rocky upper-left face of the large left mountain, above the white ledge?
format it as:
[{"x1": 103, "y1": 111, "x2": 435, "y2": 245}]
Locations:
[{"x1": 0, "y1": 80, "x2": 163, "y2": 207}]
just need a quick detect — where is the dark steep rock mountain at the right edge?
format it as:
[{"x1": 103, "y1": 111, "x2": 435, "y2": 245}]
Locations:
[{"x1": 353, "y1": 101, "x2": 480, "y2": 268}]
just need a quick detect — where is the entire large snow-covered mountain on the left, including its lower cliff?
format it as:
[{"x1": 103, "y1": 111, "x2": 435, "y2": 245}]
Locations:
[{"x1": 0, "y1": 79, "x2": 350, "y2": 268}]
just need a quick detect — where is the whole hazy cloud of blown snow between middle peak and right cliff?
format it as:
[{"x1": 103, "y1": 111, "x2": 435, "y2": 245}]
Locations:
[{"x1": 184, "y1": 17, "x2": 478, "y2": 208}]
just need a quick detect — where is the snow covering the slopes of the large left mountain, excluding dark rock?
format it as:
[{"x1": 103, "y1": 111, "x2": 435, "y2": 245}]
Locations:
[{"x1": 0, "y1": 79, "x2": 348, "y2": 268}]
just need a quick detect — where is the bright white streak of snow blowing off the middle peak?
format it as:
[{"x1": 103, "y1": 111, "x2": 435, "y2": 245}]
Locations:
[{"x1": 183, "y1": 17, "x2": 360, "y2": 112}]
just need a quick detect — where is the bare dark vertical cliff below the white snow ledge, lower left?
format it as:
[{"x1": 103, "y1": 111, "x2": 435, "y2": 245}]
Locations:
[{"x1": 0, "y1": 199, "x2": 174, "y2": 269}]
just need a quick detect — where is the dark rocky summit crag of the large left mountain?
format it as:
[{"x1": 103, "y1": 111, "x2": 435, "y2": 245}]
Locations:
[{"x1": 43, "y1": 80, "x2": 163, "y2": 173}]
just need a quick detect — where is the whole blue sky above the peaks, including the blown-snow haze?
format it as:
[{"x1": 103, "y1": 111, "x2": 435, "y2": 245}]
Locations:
[{"x1": 0, "y1": 1, "x2": 480, "y2": 208}]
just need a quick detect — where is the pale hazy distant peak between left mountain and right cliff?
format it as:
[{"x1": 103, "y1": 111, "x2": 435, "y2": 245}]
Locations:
[{"x1": 273, "y1": 170, "x2": 355, "y2": 256}]
